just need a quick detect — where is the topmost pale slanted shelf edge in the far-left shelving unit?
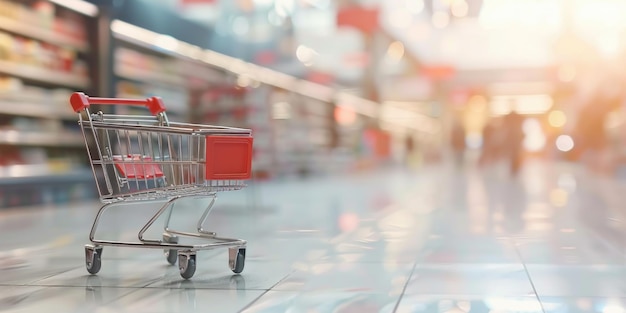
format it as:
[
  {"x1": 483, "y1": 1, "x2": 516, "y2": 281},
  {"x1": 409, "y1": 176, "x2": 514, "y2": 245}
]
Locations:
[{"x1": 0, "y1": 16, "x2": 89, "y2": 52}]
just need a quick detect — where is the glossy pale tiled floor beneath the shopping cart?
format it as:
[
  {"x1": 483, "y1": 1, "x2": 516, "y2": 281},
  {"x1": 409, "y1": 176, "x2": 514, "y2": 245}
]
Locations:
[{"x1": 0, "y1": 163, "x2": 626, "y2": 313}]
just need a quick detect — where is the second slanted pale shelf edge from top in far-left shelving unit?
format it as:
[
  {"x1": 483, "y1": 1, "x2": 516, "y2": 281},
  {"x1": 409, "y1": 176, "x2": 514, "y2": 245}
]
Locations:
[{"x1": 0, "y1": 60, "x2": 89, "y2": 89}]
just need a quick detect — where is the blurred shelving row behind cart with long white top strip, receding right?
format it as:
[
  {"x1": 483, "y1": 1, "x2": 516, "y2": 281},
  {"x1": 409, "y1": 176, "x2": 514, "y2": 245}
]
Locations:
[{"x1": 106, "y1": 20, "x2": 390, "y2": 178}]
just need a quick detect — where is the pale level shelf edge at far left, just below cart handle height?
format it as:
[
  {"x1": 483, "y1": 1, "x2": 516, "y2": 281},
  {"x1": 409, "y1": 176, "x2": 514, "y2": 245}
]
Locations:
[{"x1": 0, "y1": 130, "x2": 85, "y2": 147}]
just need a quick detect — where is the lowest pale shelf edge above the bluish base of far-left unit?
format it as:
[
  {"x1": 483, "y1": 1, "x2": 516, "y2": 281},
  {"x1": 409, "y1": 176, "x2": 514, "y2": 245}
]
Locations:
[{"x1": 0, "y1": 164, "x2": 93, "y2": 186}]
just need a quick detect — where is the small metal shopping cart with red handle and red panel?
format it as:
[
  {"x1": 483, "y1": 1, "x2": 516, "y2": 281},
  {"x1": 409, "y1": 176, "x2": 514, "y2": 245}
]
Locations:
[{"x1": 70, "y1": 92, "x2": 252, "y2": 279}]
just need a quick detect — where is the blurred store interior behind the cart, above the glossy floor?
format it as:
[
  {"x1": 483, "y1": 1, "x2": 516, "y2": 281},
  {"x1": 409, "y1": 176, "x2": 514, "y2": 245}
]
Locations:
[{"x1": 0, "y1": 0, "x2": 626, "y2": 312}]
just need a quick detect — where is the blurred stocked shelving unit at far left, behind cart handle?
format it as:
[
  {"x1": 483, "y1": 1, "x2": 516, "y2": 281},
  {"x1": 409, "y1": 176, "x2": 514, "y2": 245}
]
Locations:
[{"x1": 0, "y1": 0, "x2": 98, "y2": 208}]
